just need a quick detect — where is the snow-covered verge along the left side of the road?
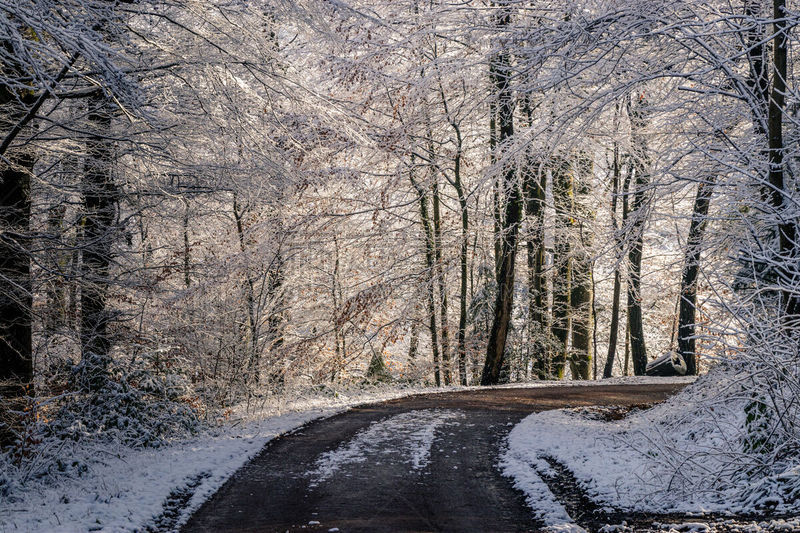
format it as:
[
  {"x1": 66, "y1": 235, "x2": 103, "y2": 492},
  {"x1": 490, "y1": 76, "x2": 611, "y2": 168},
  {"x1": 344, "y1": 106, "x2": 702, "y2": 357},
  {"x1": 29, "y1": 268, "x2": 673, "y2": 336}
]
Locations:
[{"x1": 0, "y1": 382, "x2": 450, "y2": 533}]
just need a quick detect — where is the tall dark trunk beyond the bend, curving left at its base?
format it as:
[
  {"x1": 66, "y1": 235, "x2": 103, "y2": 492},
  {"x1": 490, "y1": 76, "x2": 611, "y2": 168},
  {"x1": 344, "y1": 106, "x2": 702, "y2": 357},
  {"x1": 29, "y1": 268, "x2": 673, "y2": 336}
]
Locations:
[{"x1": 481, "y1": 7, "x2": 522, "y2": 385}]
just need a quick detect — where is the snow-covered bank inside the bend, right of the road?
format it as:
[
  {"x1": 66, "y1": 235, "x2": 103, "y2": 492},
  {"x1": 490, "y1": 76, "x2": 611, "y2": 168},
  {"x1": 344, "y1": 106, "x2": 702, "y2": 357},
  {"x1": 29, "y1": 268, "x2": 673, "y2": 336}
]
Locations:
[{"x1": 501, "y1": 373, "x2": 800, "y2": 531}]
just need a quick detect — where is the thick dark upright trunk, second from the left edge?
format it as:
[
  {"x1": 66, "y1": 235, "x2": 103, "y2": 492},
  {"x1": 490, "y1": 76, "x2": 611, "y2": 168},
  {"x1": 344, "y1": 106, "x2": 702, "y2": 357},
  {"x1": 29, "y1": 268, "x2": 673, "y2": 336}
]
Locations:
[{"x1": 80, "y1": 95, "x2": 118, "y2": 391}]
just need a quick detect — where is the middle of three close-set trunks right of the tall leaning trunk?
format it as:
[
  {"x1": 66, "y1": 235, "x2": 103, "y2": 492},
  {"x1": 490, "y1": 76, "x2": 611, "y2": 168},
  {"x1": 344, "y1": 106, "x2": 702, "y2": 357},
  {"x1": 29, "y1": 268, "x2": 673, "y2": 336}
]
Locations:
[{"x1": 551, "y1": 158, "x2": 574, "y2": 379}]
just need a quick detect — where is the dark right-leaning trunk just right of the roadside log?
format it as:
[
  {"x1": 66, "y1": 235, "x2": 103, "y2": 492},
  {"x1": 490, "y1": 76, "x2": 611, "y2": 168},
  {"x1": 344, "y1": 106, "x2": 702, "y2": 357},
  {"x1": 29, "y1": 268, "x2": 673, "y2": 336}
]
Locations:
[{"x1": 678, "y1": 177, "x2": 714, "y2": 376}]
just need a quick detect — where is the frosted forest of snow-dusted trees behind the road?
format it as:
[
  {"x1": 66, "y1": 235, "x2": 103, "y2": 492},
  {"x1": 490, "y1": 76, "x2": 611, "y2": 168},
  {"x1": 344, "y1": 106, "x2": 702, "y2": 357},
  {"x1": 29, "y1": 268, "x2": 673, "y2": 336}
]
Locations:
[{"x1": 0, "y1": 0, "x2": 800, "y2": 528}]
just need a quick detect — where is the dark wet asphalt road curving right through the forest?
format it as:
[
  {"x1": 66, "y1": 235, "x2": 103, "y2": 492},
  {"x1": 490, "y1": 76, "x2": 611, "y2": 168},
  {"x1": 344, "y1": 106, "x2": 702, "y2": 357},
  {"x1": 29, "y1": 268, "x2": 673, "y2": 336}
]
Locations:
[{"x1": 182, "y1": 384, "x2": 683, "y2": 533}]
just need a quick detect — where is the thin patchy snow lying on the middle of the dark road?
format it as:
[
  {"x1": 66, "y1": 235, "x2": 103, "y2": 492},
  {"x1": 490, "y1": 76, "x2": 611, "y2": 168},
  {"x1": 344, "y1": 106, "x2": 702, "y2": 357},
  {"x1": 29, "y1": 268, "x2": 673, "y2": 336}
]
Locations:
[{"x1": 307, "y1": 409, "x2": 464, "y2": 487}]
